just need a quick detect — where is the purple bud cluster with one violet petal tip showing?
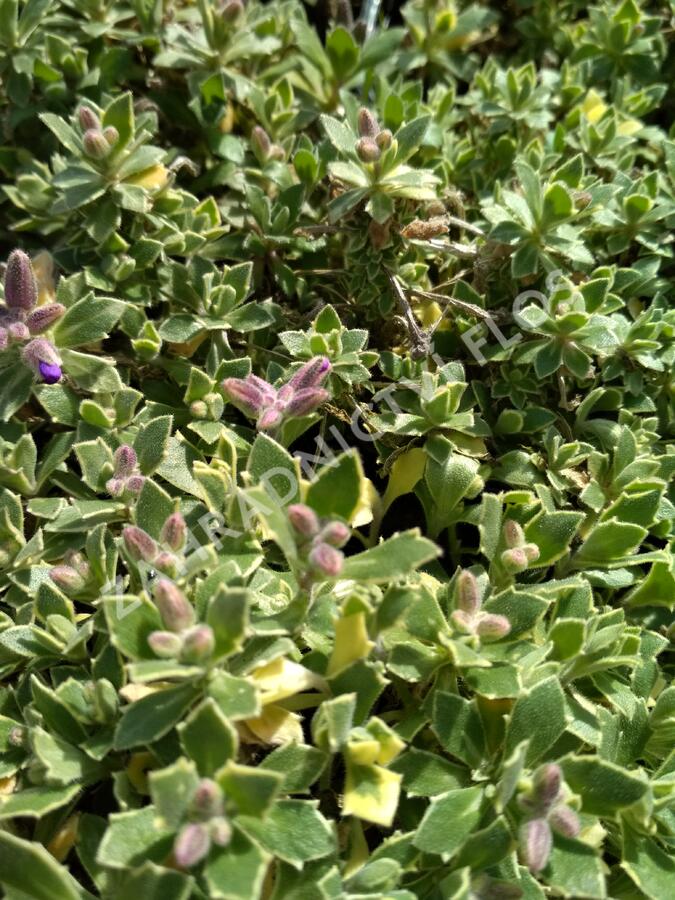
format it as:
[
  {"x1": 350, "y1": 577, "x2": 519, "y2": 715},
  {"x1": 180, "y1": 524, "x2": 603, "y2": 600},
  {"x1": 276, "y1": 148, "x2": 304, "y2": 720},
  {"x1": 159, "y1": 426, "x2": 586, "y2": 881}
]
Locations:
[{"x1": 0, "y1": 250, "x2": 66, "y2": 384}]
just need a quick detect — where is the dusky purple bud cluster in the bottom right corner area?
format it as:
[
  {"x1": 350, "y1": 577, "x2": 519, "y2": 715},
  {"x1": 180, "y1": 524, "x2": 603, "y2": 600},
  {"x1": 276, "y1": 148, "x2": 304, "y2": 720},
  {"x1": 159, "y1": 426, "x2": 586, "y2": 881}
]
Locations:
[{"x1": 518, "y1": 763, "x2": 580, "y2": 873}]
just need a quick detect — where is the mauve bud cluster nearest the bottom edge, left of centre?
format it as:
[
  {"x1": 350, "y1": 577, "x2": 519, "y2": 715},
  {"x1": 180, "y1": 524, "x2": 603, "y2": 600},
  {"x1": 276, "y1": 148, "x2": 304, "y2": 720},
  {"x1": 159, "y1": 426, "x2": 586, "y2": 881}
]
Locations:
[{"x1": 173, "y1": 778, "x2": 232, "y2": 869}]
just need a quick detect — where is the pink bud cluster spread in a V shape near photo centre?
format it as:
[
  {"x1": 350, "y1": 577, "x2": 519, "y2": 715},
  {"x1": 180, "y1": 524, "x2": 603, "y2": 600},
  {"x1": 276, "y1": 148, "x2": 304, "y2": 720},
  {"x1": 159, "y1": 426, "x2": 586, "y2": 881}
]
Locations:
[{"x1": 221, "y1": 356, "x2": 331, "y2": 432}]
